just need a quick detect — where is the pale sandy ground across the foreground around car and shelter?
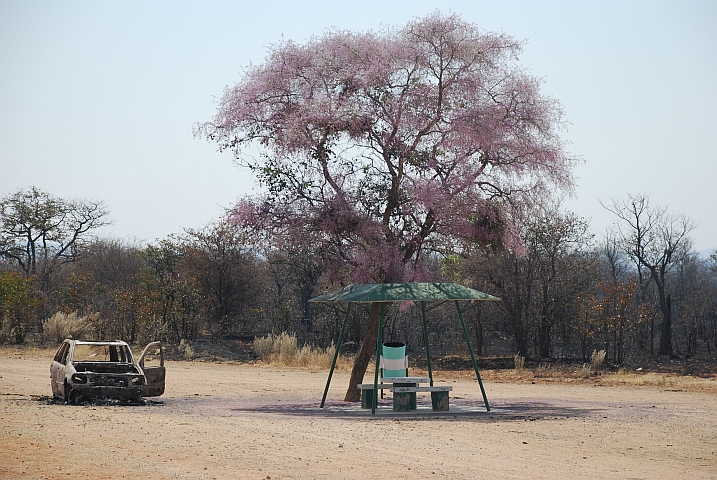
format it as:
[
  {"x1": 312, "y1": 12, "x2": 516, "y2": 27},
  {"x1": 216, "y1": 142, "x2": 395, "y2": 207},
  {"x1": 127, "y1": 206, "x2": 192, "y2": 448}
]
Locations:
[{"x1": 0, "y1": 351, "x2": 717, "y2": 479}]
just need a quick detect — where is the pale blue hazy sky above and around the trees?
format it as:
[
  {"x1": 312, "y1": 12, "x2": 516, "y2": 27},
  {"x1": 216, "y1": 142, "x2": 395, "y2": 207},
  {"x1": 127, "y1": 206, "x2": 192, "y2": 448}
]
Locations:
[{"x1": 0, "y1": 0, "x2": 717, "y2": 250}]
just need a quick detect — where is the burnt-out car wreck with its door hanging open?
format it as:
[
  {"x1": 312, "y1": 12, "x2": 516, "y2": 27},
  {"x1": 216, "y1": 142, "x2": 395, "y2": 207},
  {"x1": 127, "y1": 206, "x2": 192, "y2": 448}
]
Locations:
[{"x1": 50, "y1": 339, "x2": 165, "y2": 403}]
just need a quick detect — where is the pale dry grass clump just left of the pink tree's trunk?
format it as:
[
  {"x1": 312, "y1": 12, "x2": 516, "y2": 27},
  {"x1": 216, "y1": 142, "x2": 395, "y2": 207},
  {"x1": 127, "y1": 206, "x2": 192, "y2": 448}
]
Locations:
[{"x1": 254, "y1": 332, "x2": 353, "y2": 370}]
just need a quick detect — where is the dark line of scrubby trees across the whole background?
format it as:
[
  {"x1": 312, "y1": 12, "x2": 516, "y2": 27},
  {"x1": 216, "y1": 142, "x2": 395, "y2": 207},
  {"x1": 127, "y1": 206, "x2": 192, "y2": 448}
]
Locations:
[{"x1": 0, "y1": 188, "x2": 717, "y2": 365}]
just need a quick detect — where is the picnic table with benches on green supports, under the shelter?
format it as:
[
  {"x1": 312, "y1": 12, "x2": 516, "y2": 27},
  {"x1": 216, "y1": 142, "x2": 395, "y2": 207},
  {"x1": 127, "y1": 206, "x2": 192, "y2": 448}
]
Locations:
[{"x1": 358, "y1": 377, "x2": 453, "y2": 412}]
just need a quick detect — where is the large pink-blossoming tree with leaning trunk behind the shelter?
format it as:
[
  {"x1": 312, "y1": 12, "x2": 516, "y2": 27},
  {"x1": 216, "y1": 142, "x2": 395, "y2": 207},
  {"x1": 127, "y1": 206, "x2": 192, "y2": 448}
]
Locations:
[{"x1": 196, "y1": 12, "x2": 575, "y2": 401}]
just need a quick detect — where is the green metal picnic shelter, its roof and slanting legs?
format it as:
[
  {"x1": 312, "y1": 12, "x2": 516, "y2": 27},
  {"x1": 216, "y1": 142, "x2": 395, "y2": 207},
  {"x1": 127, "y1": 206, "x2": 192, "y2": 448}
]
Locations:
[{"x1": 309, "y1": 283, "x2": 500, "y2": 414}]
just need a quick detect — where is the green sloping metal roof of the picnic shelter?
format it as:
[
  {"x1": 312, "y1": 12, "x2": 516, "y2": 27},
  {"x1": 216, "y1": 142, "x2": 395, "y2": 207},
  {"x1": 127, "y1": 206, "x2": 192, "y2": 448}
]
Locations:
[{"x1": 309, "y1": 283, "x2": 500, "y2": 303}]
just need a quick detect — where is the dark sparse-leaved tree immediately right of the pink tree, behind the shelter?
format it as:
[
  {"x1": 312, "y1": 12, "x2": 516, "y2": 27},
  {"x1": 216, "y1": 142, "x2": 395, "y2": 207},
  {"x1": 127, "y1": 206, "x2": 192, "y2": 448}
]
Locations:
[{"x1": 465, "y1": 205, "x2": 595, "y2": 357}]
